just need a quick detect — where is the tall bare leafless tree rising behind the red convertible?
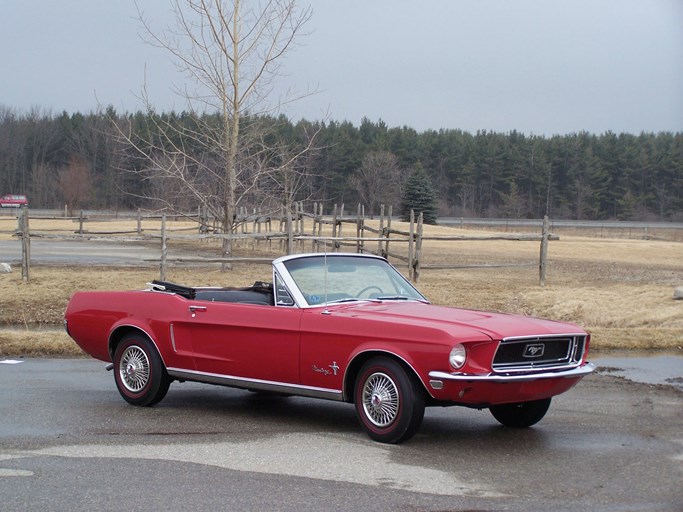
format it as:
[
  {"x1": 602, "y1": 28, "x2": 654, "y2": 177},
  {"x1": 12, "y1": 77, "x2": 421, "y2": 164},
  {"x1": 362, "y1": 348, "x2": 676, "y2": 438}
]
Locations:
[{"x1": 120, "y1": 0, "x2": 313, "y2": 255}]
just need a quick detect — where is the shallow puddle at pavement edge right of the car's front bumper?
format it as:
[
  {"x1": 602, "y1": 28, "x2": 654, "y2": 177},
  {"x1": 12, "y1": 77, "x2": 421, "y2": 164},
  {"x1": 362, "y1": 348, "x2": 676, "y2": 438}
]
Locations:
[{"x1": 588, "y1": 350, "x2": 683, "y2": 390}]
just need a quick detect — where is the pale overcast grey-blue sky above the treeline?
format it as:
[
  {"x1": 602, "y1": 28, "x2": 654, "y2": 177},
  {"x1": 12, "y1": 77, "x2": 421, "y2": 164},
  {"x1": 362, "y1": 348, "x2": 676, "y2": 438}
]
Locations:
[{"x1": 0, "y1": 0, "x2": 683, "y2": 135}]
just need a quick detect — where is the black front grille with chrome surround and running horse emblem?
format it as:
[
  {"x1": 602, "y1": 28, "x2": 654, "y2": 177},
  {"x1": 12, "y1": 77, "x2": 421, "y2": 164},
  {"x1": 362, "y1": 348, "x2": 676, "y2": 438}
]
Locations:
[{"x1": 493, "y1": 334, "x2": 586, "y2": 372}]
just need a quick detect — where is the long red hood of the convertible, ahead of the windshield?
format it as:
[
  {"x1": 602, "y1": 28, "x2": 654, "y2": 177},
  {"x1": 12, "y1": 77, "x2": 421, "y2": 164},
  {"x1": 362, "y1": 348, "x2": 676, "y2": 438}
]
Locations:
[{"x1": 328, "y1": 301, "x2": 585, "y2": 340}]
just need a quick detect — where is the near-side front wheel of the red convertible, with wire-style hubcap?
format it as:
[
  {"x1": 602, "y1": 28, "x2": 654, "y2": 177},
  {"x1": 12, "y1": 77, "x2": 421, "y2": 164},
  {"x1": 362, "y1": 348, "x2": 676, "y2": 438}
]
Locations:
[{"x1": 354, "y1": 357, "x2": 425, "y2": 444}]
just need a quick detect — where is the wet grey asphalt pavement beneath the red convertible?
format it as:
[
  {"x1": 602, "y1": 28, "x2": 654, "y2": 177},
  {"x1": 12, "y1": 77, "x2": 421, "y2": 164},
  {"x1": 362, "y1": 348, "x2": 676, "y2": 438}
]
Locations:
[{"x1": 0, "y1": 359, "x2": 683, "y2": 512}]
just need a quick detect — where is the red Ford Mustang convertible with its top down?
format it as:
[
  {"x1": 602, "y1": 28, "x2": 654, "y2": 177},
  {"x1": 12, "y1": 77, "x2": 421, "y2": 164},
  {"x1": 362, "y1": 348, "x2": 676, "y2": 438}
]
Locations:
[{"x1": 65, "y1": 253, "x2": 594, "y2": 443}]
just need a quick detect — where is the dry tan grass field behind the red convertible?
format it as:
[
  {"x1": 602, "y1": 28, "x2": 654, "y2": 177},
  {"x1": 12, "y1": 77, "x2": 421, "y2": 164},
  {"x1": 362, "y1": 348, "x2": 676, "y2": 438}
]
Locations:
[{"x1": 0, "y1": 219, "x2": 683, "y2": 356}]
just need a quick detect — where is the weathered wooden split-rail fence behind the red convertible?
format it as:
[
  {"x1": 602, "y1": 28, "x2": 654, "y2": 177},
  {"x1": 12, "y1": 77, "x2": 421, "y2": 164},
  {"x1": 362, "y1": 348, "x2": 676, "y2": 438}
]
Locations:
[{"x1": 5, "y1": 203, "x2": 559, "y2": 286}]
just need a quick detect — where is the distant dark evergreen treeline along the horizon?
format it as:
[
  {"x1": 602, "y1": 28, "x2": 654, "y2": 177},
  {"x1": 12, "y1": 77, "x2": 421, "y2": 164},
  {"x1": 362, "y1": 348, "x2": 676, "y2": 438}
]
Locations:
[{"x1": 0, "y1": 107, "x2": 683, "y2": 221}]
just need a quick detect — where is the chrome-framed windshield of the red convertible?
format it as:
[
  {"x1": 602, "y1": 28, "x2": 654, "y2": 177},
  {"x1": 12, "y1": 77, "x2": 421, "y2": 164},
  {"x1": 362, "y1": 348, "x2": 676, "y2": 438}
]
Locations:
[{"x1": 285, "y1": 255, "x2": 426, "y2": 306}]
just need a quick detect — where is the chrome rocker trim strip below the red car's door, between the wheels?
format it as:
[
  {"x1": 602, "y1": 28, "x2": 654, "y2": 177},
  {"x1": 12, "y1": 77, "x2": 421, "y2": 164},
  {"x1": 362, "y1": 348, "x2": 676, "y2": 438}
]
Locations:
[{"x1": 166, "y1": 368, "x2": 344, "y2": 402}]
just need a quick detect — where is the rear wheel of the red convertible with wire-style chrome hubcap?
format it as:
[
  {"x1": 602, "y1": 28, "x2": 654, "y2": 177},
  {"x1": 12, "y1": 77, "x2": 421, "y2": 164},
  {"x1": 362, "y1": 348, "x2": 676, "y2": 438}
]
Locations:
[{"x1": 114, "y1": 334, "x2": 171, "y2": 406}]
